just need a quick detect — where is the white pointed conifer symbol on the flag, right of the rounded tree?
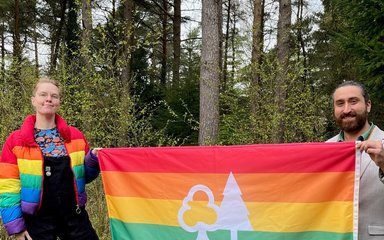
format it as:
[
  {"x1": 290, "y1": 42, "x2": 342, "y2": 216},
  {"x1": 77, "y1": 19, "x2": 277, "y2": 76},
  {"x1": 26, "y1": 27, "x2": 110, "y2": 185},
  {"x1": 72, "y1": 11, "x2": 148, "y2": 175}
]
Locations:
[{"x1": 216, "y1": 172, "x2": 253, "y2": 240}]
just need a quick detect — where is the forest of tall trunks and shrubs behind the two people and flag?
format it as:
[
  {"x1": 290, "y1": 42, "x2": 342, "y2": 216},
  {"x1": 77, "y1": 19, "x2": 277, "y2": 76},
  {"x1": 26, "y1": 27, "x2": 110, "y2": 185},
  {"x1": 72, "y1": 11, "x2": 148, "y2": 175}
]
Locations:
[{"x1": 0, "y1": 0, "x2": 384, "y2": 239}]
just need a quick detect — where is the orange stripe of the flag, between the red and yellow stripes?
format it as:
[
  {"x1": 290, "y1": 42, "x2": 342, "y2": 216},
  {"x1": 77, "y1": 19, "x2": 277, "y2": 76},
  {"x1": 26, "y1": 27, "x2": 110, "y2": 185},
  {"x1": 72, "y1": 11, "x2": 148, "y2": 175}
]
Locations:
[{"x1": 103, "y1": 171, "x2": 354, "y2": 203}]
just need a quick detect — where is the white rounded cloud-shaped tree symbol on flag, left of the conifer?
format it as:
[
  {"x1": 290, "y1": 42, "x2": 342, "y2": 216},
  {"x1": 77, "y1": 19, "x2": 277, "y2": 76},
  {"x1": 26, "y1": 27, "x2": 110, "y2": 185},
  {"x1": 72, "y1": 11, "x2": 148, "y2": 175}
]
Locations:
[{"x1": 177, "y1": 184, "x2": 219, "y2": 240}]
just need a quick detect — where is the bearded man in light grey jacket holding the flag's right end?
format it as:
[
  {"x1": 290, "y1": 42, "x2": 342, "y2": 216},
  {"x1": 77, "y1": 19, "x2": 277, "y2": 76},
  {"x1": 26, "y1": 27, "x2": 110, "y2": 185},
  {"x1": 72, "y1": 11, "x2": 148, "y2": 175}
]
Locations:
[{"x1": 327, "y1": 81, "x2": 384, "y2": 240}]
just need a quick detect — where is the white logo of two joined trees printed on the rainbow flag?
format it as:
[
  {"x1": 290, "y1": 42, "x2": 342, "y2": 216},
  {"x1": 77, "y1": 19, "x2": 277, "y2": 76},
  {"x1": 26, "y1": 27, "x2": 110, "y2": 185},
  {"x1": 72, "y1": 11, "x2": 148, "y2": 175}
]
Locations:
[{"x1": 178, "y1": 172, "x2": 253, "y2": 240}]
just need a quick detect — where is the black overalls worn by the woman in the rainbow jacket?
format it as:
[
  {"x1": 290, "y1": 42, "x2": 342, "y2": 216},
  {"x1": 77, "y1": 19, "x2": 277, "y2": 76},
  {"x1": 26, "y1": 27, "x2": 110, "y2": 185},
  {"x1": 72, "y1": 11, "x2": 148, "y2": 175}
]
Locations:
[{"x1": 24, "y1": 156, "x2": 98, "y2": 240}]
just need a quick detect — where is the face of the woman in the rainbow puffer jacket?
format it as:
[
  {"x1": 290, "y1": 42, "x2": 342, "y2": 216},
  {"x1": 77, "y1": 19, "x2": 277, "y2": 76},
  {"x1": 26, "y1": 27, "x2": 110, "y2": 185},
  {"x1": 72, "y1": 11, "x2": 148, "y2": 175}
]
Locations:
[{"x1": 32, "y1": 83, "x2": 60, "y2": 115}]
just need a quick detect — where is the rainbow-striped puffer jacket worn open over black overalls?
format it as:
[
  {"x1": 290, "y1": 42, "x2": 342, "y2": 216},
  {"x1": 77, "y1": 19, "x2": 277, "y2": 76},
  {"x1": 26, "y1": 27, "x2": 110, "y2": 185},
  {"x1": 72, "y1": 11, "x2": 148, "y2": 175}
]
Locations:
[{"x1": 0, "y1": 114, "x2": 100, "y2": 235}]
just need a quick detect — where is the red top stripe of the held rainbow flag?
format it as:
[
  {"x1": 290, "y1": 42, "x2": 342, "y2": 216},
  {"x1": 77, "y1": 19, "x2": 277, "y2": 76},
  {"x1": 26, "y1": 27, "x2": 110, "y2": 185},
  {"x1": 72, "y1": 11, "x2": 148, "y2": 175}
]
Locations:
[{"x1": 99, "y1": 142, "x2": 356, "y2": 173}]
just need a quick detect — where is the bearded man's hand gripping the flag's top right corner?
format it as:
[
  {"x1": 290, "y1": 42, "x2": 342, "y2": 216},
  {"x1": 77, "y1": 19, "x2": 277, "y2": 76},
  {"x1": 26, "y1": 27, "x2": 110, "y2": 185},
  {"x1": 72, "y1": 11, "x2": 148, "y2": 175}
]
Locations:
[{"x1": 356, "y1": 140, "x2": 384, "y2": 171}]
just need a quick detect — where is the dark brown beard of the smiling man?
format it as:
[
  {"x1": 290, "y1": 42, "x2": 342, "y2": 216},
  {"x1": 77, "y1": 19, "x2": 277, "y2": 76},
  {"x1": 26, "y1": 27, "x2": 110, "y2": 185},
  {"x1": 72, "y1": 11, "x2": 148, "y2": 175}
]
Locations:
[{"x1": 336, "y1": 110, "x2": 368, "y2": 133}]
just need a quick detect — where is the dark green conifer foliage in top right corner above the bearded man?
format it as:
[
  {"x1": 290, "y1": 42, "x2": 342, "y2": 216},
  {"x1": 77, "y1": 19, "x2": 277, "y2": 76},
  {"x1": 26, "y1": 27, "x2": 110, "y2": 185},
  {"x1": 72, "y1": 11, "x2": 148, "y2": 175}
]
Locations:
[{"x1": 333, "y1": 0, "x2": 384, "y2": 94}]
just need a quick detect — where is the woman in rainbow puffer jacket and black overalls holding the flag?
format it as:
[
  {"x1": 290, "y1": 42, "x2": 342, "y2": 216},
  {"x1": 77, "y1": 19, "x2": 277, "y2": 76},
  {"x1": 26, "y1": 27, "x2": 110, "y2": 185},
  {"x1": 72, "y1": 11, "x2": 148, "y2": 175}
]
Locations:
[{"x1": 0, "y1": 78, "x2": 100, "y2": 240}]
